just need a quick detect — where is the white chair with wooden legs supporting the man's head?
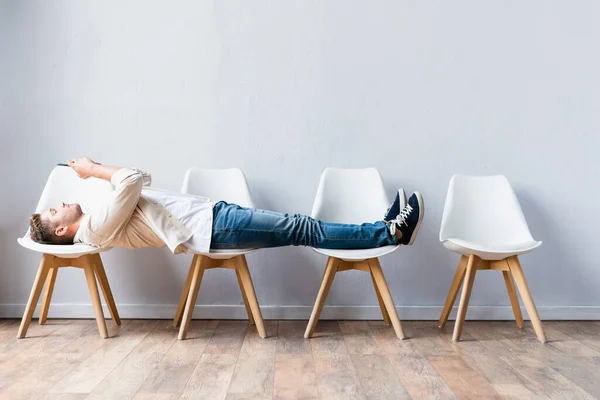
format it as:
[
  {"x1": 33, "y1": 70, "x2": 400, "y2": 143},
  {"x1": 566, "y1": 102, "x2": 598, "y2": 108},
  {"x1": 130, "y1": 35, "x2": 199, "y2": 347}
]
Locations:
[{"x1": 17, "y1": 167, "x2": 121, "y2": 338}]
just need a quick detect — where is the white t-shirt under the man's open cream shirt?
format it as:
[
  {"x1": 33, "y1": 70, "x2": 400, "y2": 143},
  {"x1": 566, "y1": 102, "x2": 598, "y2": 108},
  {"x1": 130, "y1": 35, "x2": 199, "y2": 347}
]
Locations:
[{"x1": 142, "y1": 188, "x2": 216, "y2": 253}]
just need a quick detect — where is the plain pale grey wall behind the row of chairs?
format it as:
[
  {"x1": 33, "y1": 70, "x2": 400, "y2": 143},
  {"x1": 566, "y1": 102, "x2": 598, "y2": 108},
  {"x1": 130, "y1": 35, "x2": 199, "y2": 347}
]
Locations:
[{"x1": 0, "y1": 0, "x2": 600, "y2": 318}]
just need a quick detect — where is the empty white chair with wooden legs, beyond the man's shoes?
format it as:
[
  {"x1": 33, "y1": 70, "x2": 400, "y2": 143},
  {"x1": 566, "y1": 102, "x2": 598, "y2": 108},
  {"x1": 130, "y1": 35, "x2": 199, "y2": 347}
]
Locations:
[{"x1": 439, "y1": 175, "x2": 546, "y2": 343}]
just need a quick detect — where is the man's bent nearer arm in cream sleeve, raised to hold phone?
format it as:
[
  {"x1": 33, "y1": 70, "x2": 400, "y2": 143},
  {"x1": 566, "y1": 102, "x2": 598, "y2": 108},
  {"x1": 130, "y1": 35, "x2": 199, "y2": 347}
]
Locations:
[{"x1": 69, "y1": 159, "x2": 149, "y2": 241}]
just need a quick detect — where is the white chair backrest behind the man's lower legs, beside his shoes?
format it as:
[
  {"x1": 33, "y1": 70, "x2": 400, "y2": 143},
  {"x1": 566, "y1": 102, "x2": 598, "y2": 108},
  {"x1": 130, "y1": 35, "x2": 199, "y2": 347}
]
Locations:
[{"x1": 311, "y1": 168, "x2": 391, "y2": 224}]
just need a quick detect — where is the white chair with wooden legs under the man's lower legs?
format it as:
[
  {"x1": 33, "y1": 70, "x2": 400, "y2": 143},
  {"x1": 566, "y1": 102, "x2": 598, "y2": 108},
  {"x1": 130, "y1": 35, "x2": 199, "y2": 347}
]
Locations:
[{"x1": 304, "y1": 168, "x2": 405, "y2": 339}]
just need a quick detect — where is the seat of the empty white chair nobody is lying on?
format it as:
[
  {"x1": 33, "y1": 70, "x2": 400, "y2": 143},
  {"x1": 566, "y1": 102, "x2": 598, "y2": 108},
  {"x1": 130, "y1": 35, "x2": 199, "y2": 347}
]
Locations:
[{"x1": 442, "y1": 238, "x2": 542, "y2": 260}]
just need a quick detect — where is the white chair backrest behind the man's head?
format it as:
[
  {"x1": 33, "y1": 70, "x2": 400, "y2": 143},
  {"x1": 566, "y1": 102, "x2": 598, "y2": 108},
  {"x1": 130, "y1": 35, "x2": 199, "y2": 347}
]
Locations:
[{"x1": 26, "y1": 166, "x2": 113, "y2": 235}]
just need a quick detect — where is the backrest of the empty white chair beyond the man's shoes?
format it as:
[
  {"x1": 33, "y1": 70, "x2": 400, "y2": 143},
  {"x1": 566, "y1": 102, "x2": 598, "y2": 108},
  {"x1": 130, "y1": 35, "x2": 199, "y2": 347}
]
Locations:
[{"x1": 440, "y1": 175, "x2": 533, "y2": 246}]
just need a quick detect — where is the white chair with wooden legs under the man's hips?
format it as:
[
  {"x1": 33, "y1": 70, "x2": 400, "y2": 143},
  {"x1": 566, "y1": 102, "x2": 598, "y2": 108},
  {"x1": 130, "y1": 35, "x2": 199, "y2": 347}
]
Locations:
[{"x1": 173, "y1": 168, "x2": 267, "y2": 340}]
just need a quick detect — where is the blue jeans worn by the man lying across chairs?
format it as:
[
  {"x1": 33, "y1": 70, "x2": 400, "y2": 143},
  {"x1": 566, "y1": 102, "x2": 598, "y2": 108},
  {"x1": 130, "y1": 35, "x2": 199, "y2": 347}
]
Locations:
[{"x1": 210, "y1": 201, "x2": 398, "y2": 249}]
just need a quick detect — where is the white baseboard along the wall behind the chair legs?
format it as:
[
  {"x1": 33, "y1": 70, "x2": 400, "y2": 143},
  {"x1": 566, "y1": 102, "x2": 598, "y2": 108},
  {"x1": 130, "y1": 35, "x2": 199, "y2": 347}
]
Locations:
[{"x1": 0, "y1": 303, "x2": 600, "y2": 320}]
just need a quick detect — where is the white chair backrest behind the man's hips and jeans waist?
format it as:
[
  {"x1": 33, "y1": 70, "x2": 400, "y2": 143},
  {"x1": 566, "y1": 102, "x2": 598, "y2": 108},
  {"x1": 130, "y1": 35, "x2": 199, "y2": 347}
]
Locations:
[{"x1": 181, "y1": 168, "x2": 254, "y2": 208}]
